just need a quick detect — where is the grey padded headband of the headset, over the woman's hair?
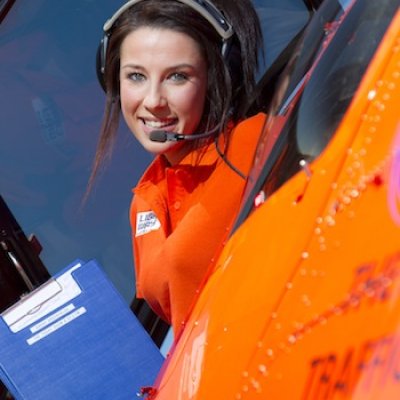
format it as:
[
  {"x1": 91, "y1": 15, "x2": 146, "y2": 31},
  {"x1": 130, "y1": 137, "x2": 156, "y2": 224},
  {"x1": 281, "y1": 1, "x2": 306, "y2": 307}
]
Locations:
[{"x1": 103, "y1": 0, "x2": 234, "y2": 41}]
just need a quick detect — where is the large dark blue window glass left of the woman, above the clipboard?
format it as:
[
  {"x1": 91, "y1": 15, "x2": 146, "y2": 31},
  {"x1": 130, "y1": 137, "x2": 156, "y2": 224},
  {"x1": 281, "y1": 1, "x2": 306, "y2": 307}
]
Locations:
[{"x1": 0, "y1": 0, "x2": 150, "y2": 301}]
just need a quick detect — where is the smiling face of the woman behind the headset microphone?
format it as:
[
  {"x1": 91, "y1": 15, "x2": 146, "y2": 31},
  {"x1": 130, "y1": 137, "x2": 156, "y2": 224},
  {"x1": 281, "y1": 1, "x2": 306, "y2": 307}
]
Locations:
[{"x1": 120, "y1": 27, "x2": 207, "y2": 164}]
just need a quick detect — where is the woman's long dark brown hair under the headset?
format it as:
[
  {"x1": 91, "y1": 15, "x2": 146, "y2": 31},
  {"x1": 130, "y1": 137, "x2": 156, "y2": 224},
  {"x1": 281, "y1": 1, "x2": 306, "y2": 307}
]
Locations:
[{"x1": 88, "y1": 0, "x2": 262, "y2": 194}]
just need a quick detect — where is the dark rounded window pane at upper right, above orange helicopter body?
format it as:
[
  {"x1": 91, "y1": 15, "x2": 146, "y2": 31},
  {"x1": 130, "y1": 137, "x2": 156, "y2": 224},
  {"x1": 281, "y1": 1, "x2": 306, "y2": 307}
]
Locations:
[{"x1": 296, "y1": 1, "x2": 398, "y2": 159}]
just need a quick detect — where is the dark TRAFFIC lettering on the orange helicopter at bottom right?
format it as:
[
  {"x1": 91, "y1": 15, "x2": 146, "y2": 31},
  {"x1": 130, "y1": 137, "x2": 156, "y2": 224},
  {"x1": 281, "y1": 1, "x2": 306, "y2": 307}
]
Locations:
[{"x1": 302, "y1": 335, "x2": 400, "y2": 400}]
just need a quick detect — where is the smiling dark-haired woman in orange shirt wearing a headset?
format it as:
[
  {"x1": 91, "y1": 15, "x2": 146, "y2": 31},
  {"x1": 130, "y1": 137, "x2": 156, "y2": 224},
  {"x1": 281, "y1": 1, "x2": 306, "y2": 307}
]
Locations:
[{"x1": 91, "y1": 0, "x2": 264, "y2": 334}]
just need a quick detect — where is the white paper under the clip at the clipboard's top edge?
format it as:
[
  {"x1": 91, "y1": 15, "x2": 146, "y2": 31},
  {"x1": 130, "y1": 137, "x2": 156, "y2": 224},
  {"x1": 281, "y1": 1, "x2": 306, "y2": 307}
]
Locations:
[{"x1": 1, "y1": 263, "x2": 82, "y2": 333}]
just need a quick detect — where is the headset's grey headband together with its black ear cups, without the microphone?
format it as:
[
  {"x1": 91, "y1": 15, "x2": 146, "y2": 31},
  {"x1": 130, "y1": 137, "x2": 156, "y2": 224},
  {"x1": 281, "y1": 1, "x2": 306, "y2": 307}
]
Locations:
[{"x1": 96, "y1": 0, "x2": 235, "y2": 91}]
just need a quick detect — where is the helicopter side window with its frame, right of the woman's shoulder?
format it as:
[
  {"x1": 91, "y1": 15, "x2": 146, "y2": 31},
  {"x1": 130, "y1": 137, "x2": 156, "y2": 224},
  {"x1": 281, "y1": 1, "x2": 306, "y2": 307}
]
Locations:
[{"x1": 236, "y1": 0, "x2": 398, "y2": 231}]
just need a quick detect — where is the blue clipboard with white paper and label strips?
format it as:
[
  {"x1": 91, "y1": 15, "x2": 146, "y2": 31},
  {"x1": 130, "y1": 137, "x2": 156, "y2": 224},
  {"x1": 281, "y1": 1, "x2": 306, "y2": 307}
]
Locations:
[{"x1": 0, "y1": 260, "x2": 164, "y2": 400}]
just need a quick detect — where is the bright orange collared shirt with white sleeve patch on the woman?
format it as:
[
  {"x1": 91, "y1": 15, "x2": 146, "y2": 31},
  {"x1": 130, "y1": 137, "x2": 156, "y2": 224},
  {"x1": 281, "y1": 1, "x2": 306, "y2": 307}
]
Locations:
[{"x1": 130, "y1": 114, "x2": 265, "y2": 334}]
